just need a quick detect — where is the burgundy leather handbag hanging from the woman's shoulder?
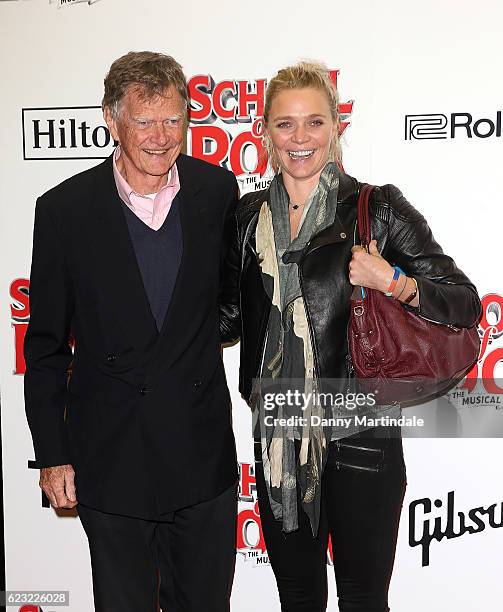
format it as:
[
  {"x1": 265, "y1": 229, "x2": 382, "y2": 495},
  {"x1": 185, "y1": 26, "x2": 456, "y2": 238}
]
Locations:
[{"x1": 348, "y1": 185, "x2": 480, "y2": 404}]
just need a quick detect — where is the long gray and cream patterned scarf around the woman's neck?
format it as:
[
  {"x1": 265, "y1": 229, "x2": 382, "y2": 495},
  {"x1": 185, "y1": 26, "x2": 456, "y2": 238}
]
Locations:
[{"x1": 253, "y1": 162, "x2": 339, "y2": 534}]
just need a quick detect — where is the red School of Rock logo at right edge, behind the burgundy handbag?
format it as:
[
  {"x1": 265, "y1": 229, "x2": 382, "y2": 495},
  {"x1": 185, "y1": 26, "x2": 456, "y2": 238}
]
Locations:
[{"x1": 448, "y1": 293, "x2": 503, "y2": 409}]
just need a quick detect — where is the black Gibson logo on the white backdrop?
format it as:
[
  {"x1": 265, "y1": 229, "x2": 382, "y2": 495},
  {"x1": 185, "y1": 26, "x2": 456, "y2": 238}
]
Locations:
[{"x1": 409, "y1": 491, "x2": 503, "y2": 567}]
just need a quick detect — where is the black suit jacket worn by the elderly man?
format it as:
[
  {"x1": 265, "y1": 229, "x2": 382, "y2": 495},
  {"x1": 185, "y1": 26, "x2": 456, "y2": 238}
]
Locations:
[{"x1": 25, "y1": 155, "x2": 241, "y2": 518}]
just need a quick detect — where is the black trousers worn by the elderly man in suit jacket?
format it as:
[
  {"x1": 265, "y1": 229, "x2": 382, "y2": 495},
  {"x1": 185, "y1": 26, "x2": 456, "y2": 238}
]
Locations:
[{"x1": 78, "y1": 485, "x2": 237, "y2": 612}]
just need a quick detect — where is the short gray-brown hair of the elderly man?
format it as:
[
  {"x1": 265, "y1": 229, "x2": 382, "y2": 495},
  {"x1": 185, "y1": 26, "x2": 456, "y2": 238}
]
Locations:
[{"x1": 101, "y1": 51, "x2": 189, "y2": 119}]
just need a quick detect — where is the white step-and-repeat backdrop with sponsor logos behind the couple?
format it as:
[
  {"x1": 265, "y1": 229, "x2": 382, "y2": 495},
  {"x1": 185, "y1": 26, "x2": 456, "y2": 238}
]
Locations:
[{"x1": 0, "y1": 0, "x2": 503, "y2": 612}]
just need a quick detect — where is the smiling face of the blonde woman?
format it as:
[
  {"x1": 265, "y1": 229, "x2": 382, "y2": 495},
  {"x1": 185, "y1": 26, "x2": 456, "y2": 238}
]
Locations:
[{"x1": 267, "y1": 88, "x2": 337, "y2": 180}]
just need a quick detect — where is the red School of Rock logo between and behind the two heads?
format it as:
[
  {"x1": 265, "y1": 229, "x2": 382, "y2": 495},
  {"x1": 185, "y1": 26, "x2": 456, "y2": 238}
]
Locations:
[{"x1": 187, "y1": 70, "x2": 353, "y2": 193}]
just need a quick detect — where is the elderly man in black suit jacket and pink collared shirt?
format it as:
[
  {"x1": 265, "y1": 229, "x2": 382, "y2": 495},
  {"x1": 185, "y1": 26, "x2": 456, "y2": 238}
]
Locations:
[{"x1": 25, "y1": 52, "x2": 237, "y2": 612}]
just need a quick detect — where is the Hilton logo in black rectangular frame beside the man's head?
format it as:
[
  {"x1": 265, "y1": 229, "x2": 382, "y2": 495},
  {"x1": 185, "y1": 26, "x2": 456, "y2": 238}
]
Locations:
[{"x1": 22, "y1": 106, "x2": 114, "y2": 160}]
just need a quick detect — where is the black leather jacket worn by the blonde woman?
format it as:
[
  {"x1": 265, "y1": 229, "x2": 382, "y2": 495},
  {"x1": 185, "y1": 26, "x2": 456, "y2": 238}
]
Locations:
[{"x1": 220, "y1": 174, "x2": 481, "y2": 401}]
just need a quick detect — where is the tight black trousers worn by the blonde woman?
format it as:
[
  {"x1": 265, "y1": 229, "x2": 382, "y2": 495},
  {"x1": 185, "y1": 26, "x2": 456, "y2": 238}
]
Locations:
[{"x1": 255, "y1": 437, "x2": 406, "y2": 612}]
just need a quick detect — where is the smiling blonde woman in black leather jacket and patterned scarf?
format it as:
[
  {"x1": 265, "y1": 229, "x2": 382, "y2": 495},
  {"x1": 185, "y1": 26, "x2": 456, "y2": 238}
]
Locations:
[{"x1": 222, "y1": 62, "x2": 480, "y2": 612}]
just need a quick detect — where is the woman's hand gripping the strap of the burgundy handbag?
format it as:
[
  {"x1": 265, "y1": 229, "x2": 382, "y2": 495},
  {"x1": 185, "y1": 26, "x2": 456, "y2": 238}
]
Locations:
[{"x1": 349, "y1": 240, "x2": 394, "y2": 293}]
